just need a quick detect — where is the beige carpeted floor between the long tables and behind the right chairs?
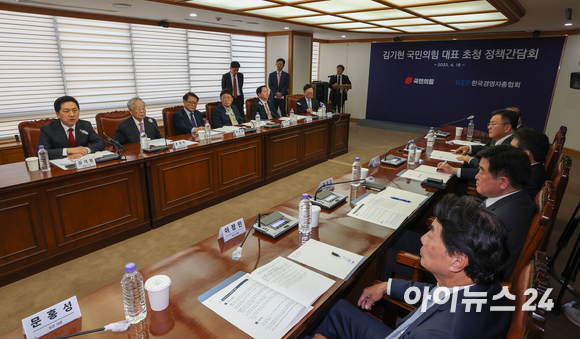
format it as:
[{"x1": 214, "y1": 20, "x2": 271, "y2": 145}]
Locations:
[{"x1": 0, "y1": 123, "x2": 580, "y2": 338}]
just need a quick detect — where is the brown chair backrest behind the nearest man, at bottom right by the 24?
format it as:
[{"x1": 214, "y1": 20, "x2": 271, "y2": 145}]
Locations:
[{"x1": 506, "y1": 251, "x2": 550, "y2": 339}]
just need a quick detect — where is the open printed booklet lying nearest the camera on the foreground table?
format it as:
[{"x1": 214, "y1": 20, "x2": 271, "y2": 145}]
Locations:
[{"x1": 203, "y1": 257, "x2": 335, "y2": 339}]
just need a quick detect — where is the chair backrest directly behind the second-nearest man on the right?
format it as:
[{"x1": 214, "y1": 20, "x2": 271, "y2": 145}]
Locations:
[{"x1": 507, "y1": 180, "x2": 556, "y2": 285}]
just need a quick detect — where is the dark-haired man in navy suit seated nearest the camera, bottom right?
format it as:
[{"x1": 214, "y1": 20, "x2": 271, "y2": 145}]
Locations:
[{"x1": 306, "y1": 195, "x2": 511, "y2": 339}]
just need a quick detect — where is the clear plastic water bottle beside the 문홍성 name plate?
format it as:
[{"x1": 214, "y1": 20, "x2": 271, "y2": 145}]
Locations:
[{"x1": 121, "y1": 262, "x2": 147, "y2": 324}]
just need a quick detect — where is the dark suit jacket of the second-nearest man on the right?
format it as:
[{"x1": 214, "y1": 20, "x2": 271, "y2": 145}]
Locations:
[{"x1": 488, "y1": 190, "x2": 536, "y2": 280}]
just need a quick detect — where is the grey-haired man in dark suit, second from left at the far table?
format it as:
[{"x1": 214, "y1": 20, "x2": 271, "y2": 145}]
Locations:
[{"x1": 114, "y1": 97, "x2": 161, "y2": 145}]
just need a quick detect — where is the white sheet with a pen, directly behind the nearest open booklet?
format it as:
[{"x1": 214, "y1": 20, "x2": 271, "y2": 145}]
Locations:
[{"x1": 288, "y1": 239, "x2": 365, "y2": 280}]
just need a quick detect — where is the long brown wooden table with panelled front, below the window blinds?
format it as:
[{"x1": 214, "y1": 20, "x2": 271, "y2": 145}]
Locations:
[{"x1": 0, "y1": 114, "x2": 350, "y2": 286}]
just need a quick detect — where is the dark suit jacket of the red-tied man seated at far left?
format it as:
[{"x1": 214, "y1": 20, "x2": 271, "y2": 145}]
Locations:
[{"x1": 36, "y1": 120, "x2": 105, "y2": 159}]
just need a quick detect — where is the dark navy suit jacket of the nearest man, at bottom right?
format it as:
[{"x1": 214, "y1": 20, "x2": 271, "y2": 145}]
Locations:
[{"x1": 390, "y1": 279, "x2": 512, "y2": 339}]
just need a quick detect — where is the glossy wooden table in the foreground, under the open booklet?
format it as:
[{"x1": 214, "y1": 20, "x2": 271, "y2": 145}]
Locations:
[{"x1": 0, "y1": 127, "x2": 490, "y2": 339}]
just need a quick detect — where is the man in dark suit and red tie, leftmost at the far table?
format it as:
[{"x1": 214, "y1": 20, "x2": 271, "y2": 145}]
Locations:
[{"x1": 36, "y1": 96, "x2": 105, "y2": 159}]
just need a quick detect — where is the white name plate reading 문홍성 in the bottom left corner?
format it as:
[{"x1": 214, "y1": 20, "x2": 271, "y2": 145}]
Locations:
[{"x1": 22, "y1": 296, "x2": 82, "y2": 338}]
